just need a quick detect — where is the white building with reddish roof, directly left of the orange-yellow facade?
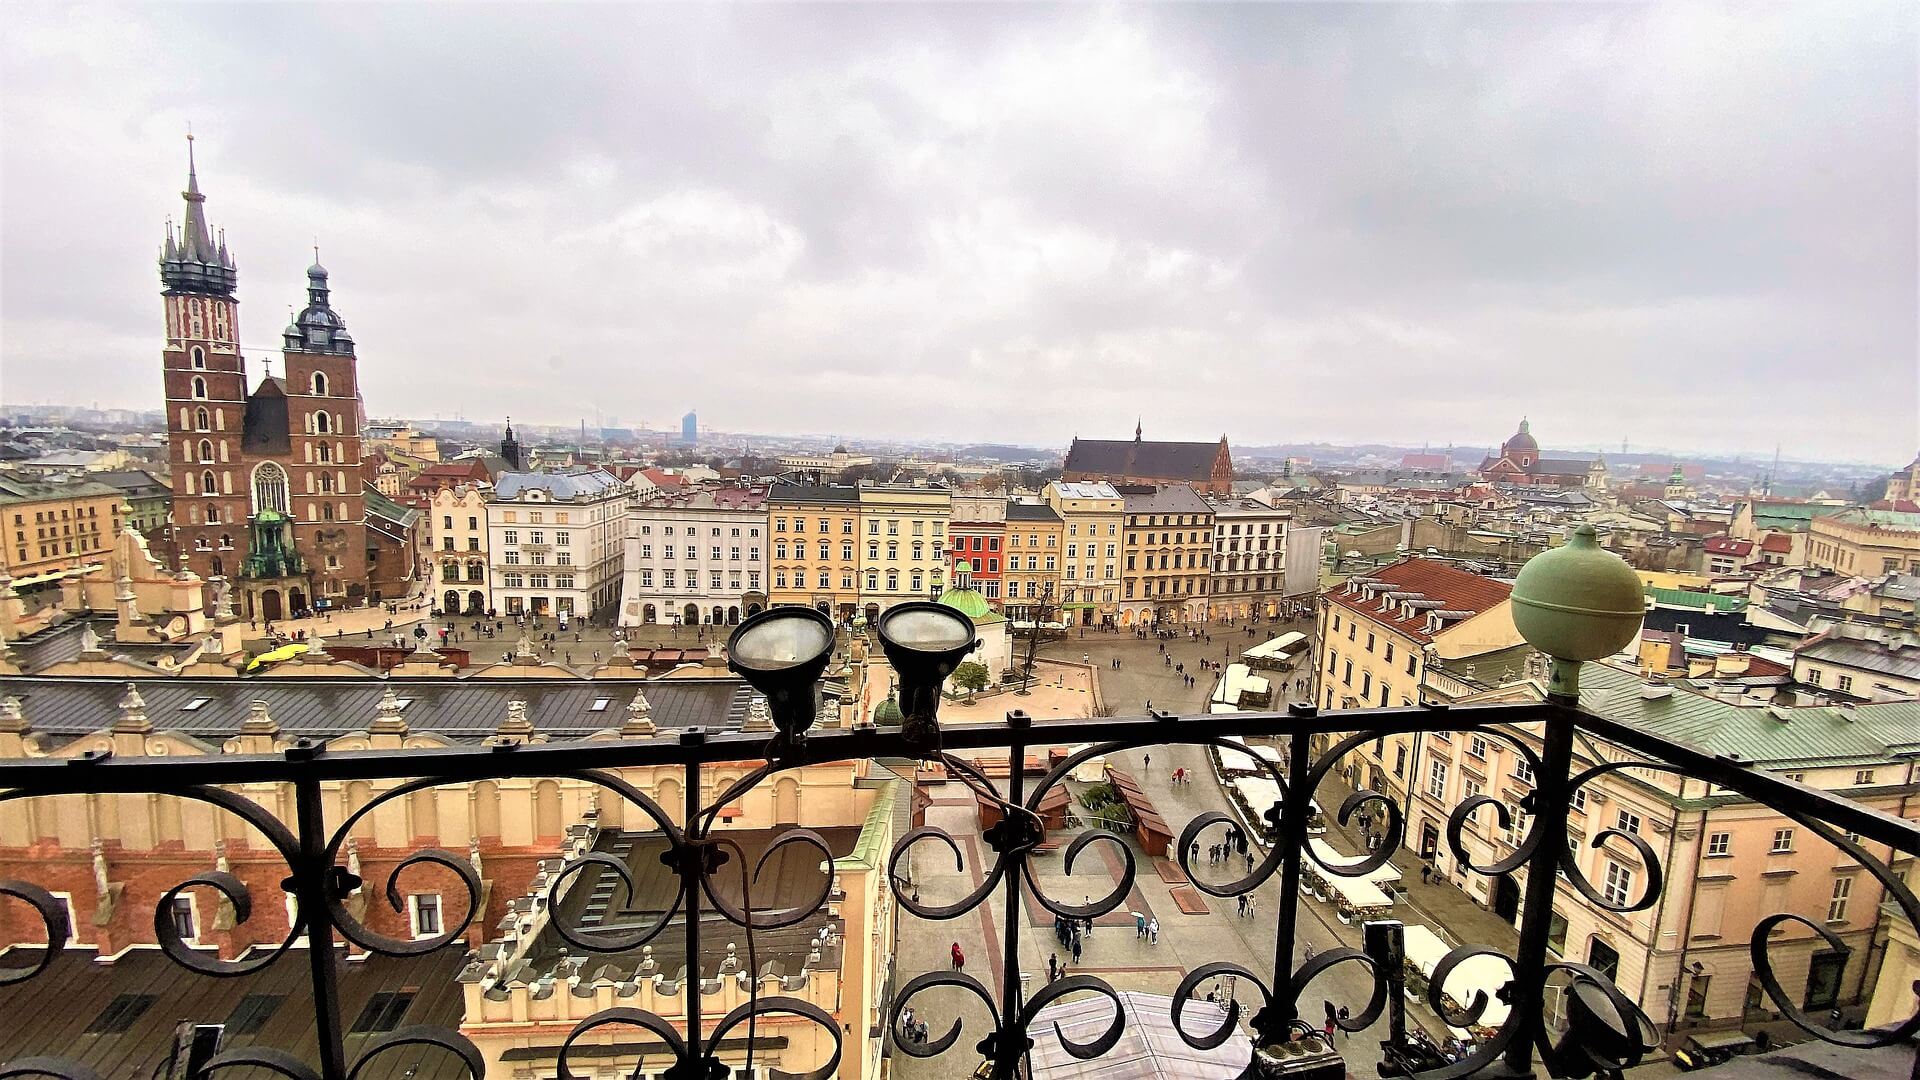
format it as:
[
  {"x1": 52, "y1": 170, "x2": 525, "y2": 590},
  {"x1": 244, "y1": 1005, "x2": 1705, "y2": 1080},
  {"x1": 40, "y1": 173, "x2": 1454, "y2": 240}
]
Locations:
[{"x1": 620, "y1": 484, "x2": 768, "y2": 626}]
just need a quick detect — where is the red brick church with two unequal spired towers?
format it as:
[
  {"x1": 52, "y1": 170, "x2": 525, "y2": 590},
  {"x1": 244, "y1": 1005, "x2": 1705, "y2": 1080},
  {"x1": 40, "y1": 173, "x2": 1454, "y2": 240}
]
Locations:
[{"x1": 159, "y1": 142, "x2": 369, "y2": 621}]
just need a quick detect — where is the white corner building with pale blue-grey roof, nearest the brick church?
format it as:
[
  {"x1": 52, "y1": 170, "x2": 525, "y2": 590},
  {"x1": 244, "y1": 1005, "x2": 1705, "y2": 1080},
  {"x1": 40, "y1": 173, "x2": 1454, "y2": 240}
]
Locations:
[{"x1": 486, "y1": 469, "x2": 630, "y2": 619}]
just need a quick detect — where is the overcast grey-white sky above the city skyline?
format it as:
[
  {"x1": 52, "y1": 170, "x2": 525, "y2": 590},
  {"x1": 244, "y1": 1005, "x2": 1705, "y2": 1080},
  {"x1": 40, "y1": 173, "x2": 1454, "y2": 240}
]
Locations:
[{"x1": 0, "y1": 2, "x2": 1920, "y2": 463}]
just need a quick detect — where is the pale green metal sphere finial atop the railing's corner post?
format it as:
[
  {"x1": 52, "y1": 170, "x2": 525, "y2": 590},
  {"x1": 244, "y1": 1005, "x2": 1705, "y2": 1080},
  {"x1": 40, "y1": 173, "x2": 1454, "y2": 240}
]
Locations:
[{"x1": 1513, "y1": 525, "x2": 1645, "y2": 703}]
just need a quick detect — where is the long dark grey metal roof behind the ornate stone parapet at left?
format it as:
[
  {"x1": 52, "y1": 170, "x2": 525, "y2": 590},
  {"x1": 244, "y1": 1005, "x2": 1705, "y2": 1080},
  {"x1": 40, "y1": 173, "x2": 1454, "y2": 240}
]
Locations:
[{"x1": 0, "y1": 676, "x2": 751, "y2": 742}]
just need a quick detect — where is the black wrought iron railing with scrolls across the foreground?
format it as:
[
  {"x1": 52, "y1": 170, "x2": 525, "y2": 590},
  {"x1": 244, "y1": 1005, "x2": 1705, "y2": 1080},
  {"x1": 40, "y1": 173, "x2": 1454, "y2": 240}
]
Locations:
[{"x1": 0, "y1": 701, "x2": 1920, "y2": 1080}]
